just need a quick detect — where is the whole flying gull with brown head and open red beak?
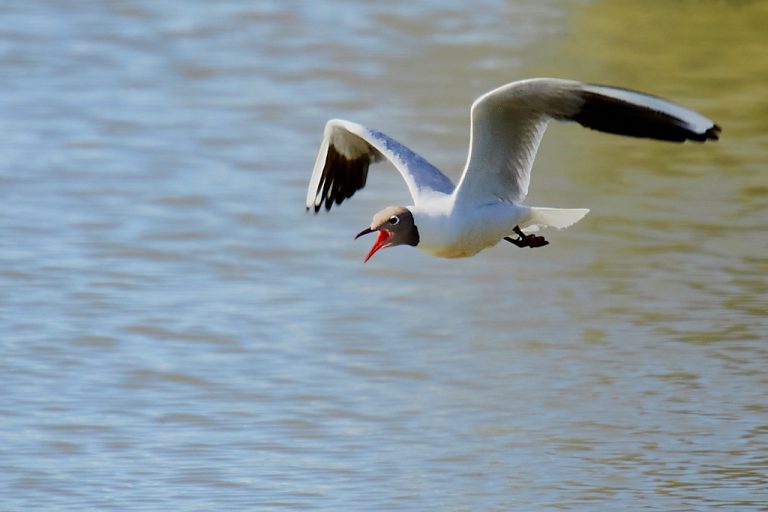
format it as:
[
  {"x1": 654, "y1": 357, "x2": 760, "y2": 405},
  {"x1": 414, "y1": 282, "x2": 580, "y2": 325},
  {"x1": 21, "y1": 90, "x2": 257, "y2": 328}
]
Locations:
[{"x1": 306, "y1": 78, "x2": 720, "y2": 262}]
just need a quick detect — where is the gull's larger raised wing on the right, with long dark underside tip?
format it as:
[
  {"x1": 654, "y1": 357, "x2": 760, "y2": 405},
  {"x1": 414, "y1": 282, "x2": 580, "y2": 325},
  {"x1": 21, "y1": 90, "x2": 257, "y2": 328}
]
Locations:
[{"x1": 456, "y1": 78, "x2": 720, "y2": 204}]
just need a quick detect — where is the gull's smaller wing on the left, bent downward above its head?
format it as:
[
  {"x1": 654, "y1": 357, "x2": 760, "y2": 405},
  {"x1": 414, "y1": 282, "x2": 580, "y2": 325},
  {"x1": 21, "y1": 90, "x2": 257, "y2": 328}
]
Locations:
[{"x1": 306, "y1": 119, "x2": 454, "y2": 213}]
